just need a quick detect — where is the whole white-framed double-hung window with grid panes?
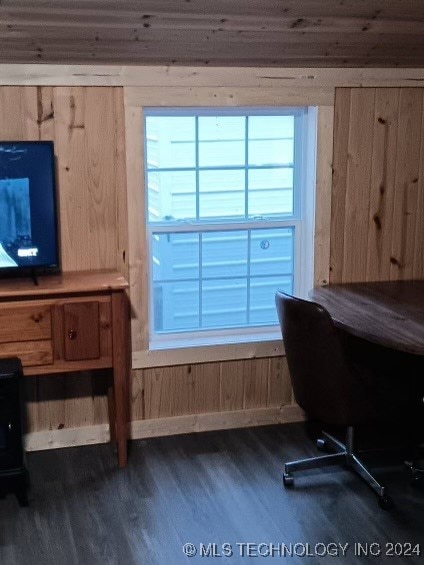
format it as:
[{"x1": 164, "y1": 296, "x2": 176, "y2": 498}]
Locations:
[{"x1": 145, "y1": 108, "x2": 315, "y2": 349}]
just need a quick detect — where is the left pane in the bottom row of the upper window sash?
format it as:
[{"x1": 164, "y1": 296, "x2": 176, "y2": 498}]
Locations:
[{"x1": 147, "y1": 171, "x2": 196, "y2": 222}]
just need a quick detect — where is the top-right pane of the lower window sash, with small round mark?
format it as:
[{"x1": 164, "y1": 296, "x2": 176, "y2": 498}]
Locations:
[{"x1": 250, "y1": 228, "x2": 294, "y2": 277}]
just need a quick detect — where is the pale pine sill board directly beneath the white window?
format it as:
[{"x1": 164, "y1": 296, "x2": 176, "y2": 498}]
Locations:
[{"x1": 132, "y1": 338, "x2": 285, "y2": 369}]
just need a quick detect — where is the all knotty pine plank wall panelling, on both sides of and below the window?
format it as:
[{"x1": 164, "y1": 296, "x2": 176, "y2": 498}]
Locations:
[{"x1": 4, "y1": 83, "x2": 424, "y2": 446}]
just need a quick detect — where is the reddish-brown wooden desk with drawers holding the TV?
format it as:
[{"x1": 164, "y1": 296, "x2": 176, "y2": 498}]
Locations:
[{"x1": 0, "y1": 271, "x2": 130, "y2": 467}]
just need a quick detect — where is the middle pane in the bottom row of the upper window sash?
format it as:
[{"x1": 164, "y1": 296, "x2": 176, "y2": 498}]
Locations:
[{"x1": 199, "y1": 170, "x2": 245, "y2": 218}]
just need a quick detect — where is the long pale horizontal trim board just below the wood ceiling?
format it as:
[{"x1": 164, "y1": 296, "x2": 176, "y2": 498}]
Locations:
[{"x1": 0, "y1": 64, "x2": 424, "y2": 88}]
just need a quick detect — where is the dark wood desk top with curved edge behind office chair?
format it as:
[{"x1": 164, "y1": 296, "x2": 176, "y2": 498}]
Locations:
[{"x1": 310, "y1": 281, "x2": 424, "y2": 355}]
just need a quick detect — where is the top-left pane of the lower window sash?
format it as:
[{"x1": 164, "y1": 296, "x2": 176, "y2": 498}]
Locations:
[{"x1": 151, "y1": 233, "x2": 199, "y2": 281}]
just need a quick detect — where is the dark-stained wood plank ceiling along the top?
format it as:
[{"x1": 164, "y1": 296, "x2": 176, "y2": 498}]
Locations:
[{"x1": 0, "y1": 0, "x2": 424, "y2": 67}]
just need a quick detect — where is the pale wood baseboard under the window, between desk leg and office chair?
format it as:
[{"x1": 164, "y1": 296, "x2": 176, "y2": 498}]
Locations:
[{"x1": 130, "y1": 405, "x2": 305, "y2": 439}]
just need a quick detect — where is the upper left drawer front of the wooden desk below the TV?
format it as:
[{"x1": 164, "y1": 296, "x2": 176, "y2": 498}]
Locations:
[{"x1": 0, "y1": 303, "x2": 52, "y2": 343}]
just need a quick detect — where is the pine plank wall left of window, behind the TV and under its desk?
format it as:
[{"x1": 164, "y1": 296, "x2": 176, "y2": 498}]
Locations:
[{"x1": 0, "y1": 87, "x2": 127, "y2": 431}]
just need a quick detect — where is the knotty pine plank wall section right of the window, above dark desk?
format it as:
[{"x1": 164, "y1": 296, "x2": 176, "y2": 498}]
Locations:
[{"x1": 330, "y1": 88, "x2": 424, "y2": 283}]
